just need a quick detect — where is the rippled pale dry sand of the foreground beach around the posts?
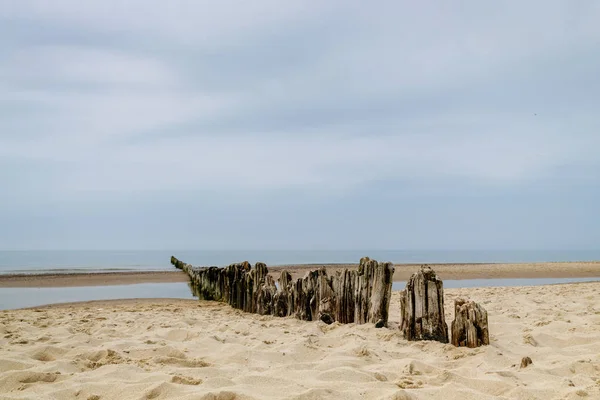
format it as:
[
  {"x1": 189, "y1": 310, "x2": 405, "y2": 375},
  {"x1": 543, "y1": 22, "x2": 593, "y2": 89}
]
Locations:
[{"x1": 0, "y1": 282, "x2": 600, "y2": 400}]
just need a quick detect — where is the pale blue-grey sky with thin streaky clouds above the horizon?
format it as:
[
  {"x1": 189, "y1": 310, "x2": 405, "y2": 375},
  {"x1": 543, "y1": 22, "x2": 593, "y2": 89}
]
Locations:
[{"x1": 0, "y1": 0, "x2": 600, "y2": 250}]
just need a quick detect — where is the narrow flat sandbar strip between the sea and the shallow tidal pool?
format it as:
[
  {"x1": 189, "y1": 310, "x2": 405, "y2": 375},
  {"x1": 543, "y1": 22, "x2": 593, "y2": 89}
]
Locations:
[{"x1": 0, "y1": 261, "x2": 600, "y2": 288}]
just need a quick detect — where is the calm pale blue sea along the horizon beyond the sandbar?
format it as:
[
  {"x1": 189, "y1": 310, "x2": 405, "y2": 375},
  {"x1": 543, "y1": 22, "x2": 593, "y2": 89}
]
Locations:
[{"x1": 0, "y1": 250, "x2": 600, "y2": 274}]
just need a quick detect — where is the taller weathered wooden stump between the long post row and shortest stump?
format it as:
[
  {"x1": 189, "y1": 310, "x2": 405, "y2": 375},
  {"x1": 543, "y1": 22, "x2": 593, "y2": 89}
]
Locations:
[{"x1": 400, "y1": 266, "x2": 448, "y2": 343}]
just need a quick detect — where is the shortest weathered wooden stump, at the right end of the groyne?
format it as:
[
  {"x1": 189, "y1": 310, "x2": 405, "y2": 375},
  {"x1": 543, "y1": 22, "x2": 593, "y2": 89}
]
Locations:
[{"x1": 452, "y1": 299, "x2": 490, "y2": 347}]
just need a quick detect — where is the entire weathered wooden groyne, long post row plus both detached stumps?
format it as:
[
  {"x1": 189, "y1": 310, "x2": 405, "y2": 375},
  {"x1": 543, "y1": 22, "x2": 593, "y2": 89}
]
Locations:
[{"x1": 171, "y1": 257, "x2": 490, "y2": 347}]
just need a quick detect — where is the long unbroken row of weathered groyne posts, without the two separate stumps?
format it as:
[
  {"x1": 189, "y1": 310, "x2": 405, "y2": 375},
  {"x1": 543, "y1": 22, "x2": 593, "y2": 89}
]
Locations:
[{"x1": 171, "y1": 257, "x2": 394, "y2": 327}]
